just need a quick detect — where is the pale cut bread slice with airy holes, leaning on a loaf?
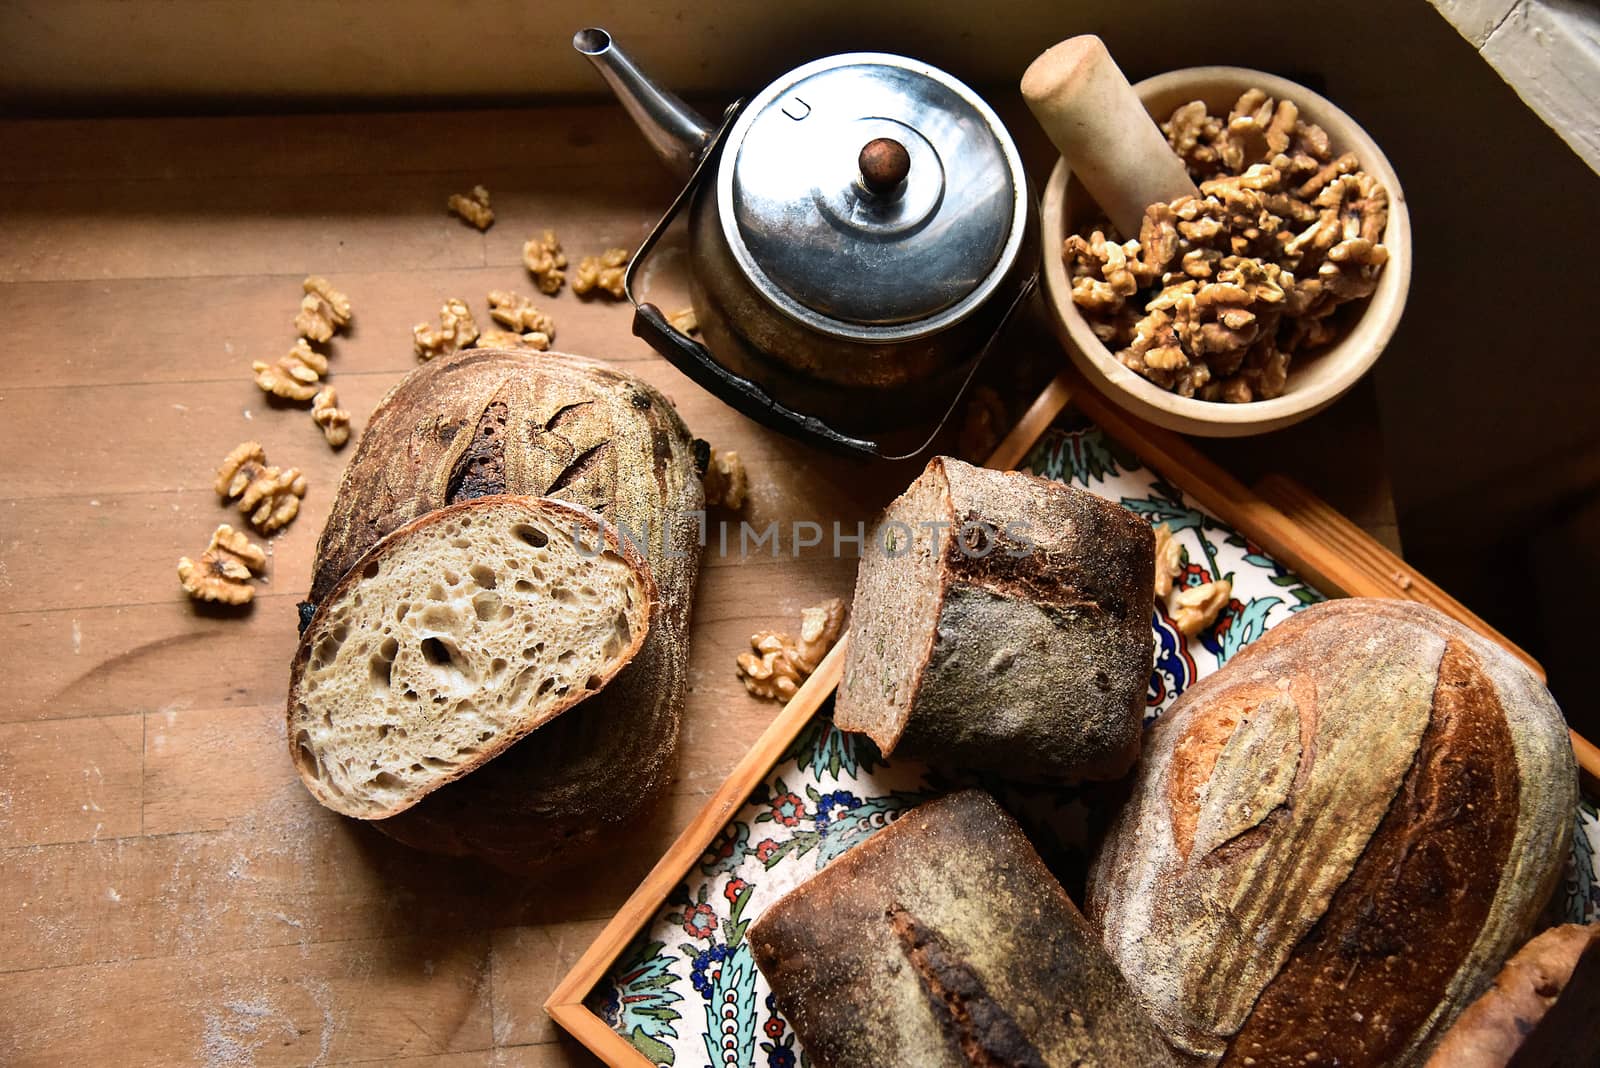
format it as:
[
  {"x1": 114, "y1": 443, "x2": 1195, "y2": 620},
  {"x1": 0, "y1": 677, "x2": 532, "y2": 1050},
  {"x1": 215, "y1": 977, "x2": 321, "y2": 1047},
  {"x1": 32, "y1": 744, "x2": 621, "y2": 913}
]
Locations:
[{"x1": 288, "y1": 496, "x2": 656, "y2": 820}]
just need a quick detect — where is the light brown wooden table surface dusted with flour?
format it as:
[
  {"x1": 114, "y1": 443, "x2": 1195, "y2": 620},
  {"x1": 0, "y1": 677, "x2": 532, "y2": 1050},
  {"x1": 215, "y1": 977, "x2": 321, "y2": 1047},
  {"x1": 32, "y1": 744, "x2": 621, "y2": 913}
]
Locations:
[{"x1": 0, "y1": 107, "x2": 1395, "y2": 1068}]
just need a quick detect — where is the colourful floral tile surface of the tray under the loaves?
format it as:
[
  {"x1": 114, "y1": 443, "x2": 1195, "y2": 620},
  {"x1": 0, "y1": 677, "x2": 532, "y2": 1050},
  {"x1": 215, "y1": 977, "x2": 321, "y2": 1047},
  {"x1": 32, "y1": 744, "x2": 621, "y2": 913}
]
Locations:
[{"x1": 589, "y1": 424, "x2": 1600, "y2": 1068}]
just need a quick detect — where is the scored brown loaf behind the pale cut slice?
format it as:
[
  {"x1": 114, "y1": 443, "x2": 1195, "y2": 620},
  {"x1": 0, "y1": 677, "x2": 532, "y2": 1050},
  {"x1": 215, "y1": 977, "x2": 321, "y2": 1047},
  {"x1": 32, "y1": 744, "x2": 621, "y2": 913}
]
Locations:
[{"x1": 297, "y1": 350, "x2": 706, "y2": 871}]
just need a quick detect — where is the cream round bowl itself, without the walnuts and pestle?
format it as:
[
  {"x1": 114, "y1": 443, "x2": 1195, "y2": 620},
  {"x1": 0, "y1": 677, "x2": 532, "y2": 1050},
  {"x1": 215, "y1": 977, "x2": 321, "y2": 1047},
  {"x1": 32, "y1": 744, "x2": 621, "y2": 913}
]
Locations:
[{"x1": 1042, "y1": 67, "x2": 1411, "y2": 438}]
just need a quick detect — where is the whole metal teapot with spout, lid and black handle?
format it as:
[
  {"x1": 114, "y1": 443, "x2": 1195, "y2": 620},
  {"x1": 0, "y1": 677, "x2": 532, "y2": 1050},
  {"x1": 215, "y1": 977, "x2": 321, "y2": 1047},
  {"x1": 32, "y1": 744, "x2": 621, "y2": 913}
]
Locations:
[{"x1": 573, "y1": 29, "x2": 1038, "y2": 459}]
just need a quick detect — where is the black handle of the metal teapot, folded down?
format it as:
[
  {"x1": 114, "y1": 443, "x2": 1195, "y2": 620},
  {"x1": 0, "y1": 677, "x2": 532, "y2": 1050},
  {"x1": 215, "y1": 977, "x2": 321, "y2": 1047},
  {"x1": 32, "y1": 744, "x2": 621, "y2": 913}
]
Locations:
[{"x1": 622, "y1": 101, "x2": 883, "y2": 459}]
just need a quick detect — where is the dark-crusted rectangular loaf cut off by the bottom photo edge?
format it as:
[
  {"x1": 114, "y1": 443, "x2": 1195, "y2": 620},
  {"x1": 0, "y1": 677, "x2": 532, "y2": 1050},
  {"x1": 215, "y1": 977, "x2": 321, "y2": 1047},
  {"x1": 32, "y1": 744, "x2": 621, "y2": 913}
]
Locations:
[{"x1": 749, "y1": 790, "x2": 1173, "y2": 1068}]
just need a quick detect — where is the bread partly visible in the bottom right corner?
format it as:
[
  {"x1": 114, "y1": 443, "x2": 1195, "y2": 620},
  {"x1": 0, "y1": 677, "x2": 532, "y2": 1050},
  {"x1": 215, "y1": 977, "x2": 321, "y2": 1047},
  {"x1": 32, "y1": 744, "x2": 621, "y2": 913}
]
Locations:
[{"x1": 1427, "y1": 924, "x2": 1600, "y2": 1068}]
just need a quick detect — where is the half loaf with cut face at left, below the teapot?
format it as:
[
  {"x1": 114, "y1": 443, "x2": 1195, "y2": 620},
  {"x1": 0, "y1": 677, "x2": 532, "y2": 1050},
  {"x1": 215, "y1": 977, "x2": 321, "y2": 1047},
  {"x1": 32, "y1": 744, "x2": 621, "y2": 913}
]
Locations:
[{"x1": 834, "y1": 457, "x2": 1155, "y2": 780}]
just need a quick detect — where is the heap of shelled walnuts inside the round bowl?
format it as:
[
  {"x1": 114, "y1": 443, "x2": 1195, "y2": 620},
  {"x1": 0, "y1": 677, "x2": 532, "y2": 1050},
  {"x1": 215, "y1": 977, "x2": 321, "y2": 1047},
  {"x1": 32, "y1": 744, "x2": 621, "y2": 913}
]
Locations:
[{"x1": 1062, "y1": 90, "x2": 1389, "y2": 403}]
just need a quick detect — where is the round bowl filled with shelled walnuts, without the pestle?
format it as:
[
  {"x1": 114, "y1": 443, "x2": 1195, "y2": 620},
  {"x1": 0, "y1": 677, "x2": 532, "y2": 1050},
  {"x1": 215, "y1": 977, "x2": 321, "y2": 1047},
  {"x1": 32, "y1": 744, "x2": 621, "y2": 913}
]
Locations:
[{"x1": 1042, "y1": 67, "x2": 1411, "y2": 436}]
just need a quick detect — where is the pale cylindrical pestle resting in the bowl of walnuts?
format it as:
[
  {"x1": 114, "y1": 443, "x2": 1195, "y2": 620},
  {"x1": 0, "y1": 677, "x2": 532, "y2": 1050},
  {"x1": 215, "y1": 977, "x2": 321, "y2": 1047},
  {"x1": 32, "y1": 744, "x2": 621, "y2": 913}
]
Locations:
[{"x1": 1022, "y1": 34, "x2": 1197, "y2": 240}]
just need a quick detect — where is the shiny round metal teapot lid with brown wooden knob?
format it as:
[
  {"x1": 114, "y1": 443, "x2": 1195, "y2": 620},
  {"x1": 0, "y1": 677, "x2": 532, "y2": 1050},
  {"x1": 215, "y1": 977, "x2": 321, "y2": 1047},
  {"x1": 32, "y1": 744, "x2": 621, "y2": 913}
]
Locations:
[{"x1": 717, "y1": 53, "x2": 1027, "y2": 341}]
